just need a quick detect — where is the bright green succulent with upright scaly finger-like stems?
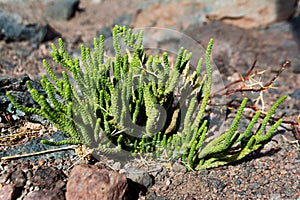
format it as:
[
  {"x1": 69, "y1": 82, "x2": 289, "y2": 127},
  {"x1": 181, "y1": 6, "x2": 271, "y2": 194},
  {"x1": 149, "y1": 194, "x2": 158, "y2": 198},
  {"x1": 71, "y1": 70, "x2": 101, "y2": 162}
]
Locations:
[{"x1": 7, "y1": 26, "x2": 286, "y2": 170}]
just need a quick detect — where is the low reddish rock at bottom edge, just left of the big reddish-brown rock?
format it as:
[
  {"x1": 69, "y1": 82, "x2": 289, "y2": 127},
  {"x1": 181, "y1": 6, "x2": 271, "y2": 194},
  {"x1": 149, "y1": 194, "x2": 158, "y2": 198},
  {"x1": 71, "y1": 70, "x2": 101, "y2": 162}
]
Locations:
[{"x1": 25, "y1": 189, "x2": 66, "y2": 200}]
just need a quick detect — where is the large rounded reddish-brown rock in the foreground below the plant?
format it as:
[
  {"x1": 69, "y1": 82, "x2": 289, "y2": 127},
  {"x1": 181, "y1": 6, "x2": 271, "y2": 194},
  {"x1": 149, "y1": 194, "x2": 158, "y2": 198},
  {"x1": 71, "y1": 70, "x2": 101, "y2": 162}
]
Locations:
[{"x1": 66, "y1": 164, "x2": 129, "y2": 200}]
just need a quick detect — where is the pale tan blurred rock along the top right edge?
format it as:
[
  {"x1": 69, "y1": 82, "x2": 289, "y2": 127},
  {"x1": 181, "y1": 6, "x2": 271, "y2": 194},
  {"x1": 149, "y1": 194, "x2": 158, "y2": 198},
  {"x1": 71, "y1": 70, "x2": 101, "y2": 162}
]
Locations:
[{"x1": 203, "y1": 0, "x2": 297, "y2": 28}]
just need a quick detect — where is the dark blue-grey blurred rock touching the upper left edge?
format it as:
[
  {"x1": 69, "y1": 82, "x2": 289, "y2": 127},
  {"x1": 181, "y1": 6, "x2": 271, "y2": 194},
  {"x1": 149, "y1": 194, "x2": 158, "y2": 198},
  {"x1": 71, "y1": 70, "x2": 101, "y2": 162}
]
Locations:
[{"x1": 0, "y1": 9, "x2": 59, "y2": 43}]
